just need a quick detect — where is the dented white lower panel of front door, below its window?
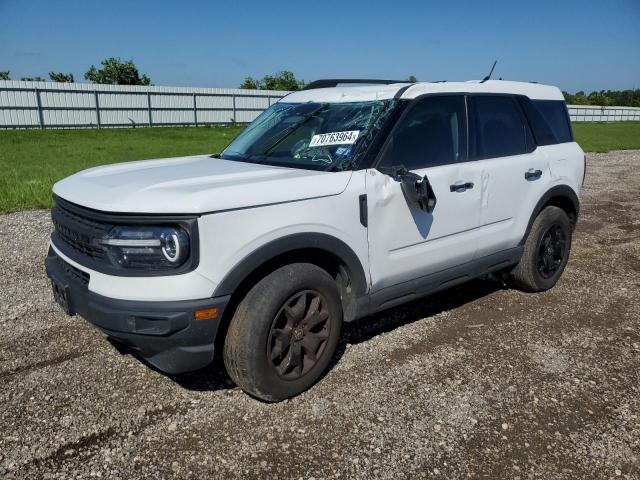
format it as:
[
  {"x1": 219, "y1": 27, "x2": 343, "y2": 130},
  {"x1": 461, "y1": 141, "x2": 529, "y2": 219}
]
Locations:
[{"x1": 366, "y1": 162, "x2": 481, "y2": 291}]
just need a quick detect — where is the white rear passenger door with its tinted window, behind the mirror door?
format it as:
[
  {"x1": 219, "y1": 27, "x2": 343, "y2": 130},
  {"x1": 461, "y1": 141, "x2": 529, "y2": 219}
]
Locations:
[{"x1": 468, "y1": 94, "x2": 550, "y2": 258}]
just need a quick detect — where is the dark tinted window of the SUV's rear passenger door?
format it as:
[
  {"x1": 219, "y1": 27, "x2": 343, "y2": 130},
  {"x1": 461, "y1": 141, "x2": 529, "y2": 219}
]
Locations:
[{"x1": 469, "y1": 95, "x2": 535, "y2": 159}]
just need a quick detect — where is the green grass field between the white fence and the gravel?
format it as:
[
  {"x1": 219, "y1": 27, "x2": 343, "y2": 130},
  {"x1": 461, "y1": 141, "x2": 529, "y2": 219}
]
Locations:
[{"x1": 0, "y1": 122, "x2": 640, "y2": 212}]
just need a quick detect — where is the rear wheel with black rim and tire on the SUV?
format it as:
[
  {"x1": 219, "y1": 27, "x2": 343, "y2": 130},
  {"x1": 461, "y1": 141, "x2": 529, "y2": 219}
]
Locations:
[{"x1": 509, "y1": 206, "x2": 571, "y2": 292}]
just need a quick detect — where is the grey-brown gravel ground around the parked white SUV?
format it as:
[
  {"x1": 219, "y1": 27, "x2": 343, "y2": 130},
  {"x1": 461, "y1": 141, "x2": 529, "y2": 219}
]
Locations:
[{"x1": 0, "y1": 151, "x2": 640, "y2": 480}]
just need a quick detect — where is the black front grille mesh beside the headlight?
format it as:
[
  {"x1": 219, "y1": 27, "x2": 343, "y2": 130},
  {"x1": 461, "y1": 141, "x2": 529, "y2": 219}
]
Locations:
[{"x1": 51, "y1": 199, "x2": 112, "y2": 260}]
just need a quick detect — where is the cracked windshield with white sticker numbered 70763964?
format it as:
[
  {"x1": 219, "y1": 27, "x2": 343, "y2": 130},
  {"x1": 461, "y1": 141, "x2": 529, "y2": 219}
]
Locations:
[{"x1": 221, "y1": 100, "x2": 397, "y2": 171}]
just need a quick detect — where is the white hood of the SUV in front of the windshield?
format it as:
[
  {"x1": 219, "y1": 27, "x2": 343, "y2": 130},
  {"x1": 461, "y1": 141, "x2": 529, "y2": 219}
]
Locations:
[{"x1": 53, "y1": 155, "x2": 351, "y2": 214}]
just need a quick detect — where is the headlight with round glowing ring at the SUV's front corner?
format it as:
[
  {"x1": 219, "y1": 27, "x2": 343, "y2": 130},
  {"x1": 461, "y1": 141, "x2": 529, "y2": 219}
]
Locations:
[{"x1": 98, "y1": 225, "x2": 190, "y2": 270}]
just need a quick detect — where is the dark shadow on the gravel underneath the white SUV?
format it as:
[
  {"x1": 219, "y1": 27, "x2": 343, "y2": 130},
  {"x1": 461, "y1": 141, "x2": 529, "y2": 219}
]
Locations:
[{"x1": 165, "y1": 280, "x2": 505, "y2": 391}]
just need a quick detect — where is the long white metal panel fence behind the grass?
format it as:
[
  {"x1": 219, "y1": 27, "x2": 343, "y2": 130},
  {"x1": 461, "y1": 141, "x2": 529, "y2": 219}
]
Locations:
[{"x1": 0, "y1": 80, "x2": 640, "y2": 129}]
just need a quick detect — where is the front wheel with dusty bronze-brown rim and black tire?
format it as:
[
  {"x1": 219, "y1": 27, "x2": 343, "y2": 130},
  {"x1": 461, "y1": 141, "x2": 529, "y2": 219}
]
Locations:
[{"x1": 223, "y1": 263, "x2": 342, "y2": 402}]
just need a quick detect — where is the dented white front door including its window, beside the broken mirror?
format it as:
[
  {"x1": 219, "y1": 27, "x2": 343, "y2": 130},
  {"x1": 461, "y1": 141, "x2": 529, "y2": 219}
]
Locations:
[{"x1": 366, "y1": 95, "x2": 481, "y2": 291}]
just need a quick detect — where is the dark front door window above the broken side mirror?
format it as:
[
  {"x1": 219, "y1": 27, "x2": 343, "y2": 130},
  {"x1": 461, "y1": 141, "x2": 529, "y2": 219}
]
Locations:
[{"x1": 381, "y1": 95, "x2": 467, "y2": 170}]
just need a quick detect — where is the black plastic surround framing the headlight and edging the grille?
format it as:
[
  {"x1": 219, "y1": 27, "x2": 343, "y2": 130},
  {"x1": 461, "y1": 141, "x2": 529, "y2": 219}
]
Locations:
[{"x1": 51, "y1": 195, "x2": 200, "y2": 277}]
